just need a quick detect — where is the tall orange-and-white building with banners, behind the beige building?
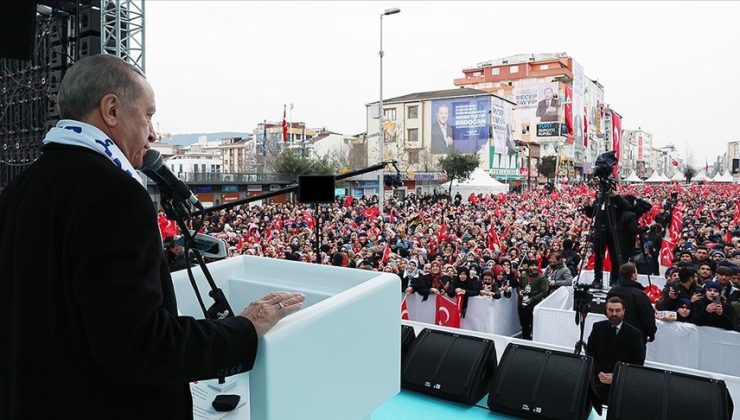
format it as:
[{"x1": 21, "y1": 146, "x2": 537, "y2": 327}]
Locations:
[{"x1": 454, "y1": 53, "x2": 612, "y2": 177}]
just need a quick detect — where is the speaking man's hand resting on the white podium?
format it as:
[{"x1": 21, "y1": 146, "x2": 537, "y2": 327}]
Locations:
[{"x1": 239, "y1": 292, "x2": 306, "y2": 337}]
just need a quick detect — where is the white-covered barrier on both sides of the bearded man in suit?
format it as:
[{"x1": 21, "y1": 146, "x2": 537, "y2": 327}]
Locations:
[{"x1": 533, "y1": 287, "x2": 740, "y2": 376}]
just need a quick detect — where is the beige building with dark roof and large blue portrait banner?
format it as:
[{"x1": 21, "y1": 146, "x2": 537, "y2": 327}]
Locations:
[{"x1": 366, "y1": 88, "x2": 523, "y2": 188}]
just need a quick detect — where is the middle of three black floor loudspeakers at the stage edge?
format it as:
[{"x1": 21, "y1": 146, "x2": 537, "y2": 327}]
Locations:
[{"x1": 488, "y1": 343, "x2": 594, "y2": 419}]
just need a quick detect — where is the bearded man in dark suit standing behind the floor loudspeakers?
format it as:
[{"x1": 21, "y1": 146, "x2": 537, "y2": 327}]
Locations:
[{"x1": 586, "y1": 296, "x2": 645, "y2": 404}]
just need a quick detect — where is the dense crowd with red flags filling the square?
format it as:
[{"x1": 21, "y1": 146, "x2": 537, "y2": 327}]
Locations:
[{"x1": 160, "y1": 184, "x2": 740, "y2": 337}]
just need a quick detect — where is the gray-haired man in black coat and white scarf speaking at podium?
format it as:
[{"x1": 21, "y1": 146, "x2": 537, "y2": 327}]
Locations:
[{"x1": 0, "y1": 55, "x2": 304, "y2": 419}]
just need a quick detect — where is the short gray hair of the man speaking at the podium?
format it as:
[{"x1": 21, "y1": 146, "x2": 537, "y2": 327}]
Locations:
[{"x1": 57, "y1": 54, "x2": 145, "y2": 121}]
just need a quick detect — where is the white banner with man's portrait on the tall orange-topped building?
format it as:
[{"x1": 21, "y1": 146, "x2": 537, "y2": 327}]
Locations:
[{"x1": 514, "y1": 82, "x2": 561, "y2": 123}]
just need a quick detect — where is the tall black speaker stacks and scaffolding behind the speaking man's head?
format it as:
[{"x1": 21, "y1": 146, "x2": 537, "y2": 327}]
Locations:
[{"x1": 0, "y1": 4, "x2": 101, "y2": 189}]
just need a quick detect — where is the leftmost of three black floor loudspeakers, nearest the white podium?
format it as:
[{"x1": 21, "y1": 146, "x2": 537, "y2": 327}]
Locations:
[{"x1": 401, "y1": 328, "x2": 496, "y2": 405}]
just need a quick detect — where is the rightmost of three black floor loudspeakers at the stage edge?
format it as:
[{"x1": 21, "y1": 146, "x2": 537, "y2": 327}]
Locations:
[{"x1": 606, "y1": 363, "x2": 733, "y2": 420}]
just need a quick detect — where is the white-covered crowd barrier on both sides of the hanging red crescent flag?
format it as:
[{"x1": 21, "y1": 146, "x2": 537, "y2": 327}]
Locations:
[{"x1": 406, "y1": 290, "x2": 521, "y2": 336}]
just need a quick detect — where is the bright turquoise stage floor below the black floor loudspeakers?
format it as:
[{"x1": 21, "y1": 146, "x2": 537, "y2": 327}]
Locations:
[{"x1": 372, "y1": 389, "x2": 606, "y2": 420}]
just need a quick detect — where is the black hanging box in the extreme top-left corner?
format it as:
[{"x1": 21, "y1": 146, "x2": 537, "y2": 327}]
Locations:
[{"x1": 0, "y1": 0, "x2": 36, "y2": 60}]
